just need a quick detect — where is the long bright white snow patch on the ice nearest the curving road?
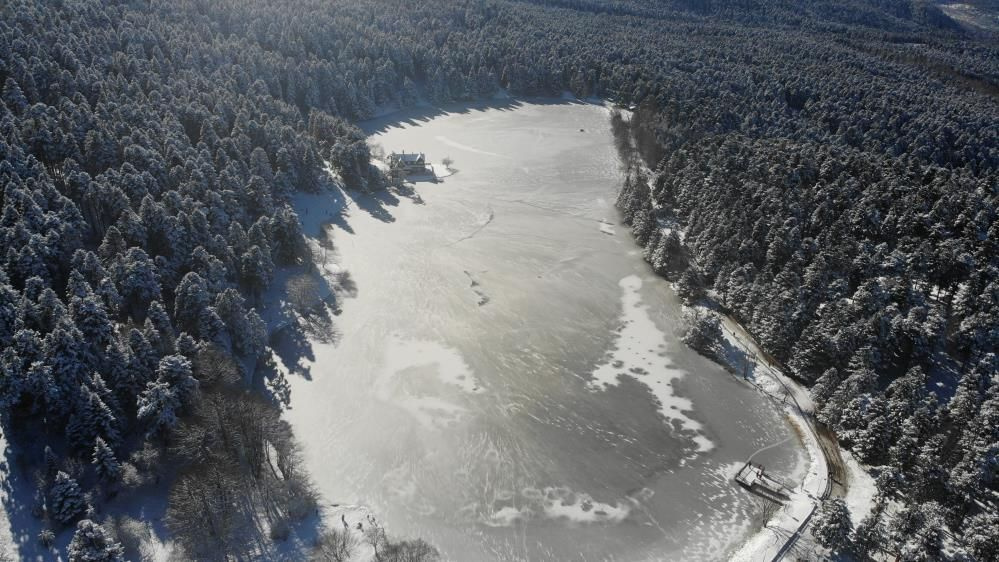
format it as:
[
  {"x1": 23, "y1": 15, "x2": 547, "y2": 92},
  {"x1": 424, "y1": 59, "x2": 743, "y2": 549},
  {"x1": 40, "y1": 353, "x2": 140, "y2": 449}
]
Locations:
[{"x1": 589, "y1": 275, "x2": 714, "y2": 452}]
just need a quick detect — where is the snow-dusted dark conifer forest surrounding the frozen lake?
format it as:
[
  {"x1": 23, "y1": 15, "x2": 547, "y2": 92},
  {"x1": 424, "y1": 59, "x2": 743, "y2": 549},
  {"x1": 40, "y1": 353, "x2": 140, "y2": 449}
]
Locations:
[{"x1": 0, "y1": 0, "x2": 999, "y2": 560}]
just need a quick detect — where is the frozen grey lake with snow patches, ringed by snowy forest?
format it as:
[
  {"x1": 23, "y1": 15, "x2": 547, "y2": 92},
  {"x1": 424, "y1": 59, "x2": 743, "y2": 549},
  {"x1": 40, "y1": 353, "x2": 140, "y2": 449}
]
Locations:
[{"x1": 287, "y1": 98, "x2": 805, "y2": 561}]
